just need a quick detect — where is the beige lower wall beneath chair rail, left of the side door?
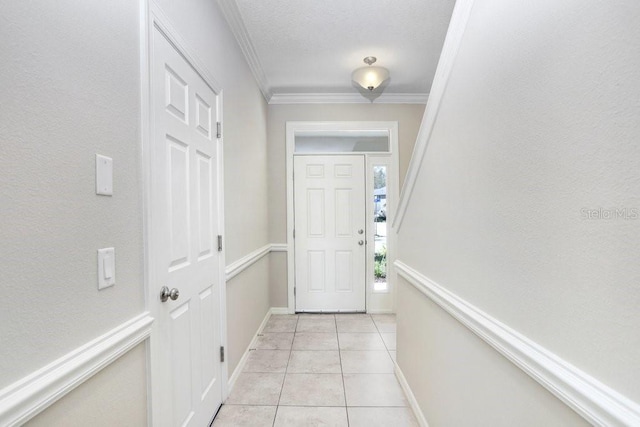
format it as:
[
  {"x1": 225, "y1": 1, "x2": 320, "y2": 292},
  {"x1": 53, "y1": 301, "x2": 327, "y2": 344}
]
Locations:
[{"x1": 25, "y1": 344, "x2": 147, "y2": 427}]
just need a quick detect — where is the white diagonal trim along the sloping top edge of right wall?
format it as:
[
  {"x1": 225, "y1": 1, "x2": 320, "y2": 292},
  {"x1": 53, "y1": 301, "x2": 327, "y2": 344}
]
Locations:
[{"x1": 393, "y1": 0, "x2": 474, "y2": 233}]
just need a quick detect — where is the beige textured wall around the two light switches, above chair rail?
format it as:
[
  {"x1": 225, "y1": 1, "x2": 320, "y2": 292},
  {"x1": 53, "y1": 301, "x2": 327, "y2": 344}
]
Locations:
[{"x1": 0, "y1": 0, "x2": 145, "y2": 388}]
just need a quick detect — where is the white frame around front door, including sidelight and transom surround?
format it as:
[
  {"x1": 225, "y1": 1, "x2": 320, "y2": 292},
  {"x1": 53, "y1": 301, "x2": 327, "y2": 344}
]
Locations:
[{"x1": 286, "y1": 121, "x2": 400, "y2": 314}]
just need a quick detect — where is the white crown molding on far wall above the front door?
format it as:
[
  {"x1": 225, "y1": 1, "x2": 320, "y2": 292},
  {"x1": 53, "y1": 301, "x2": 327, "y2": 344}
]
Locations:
[{"x1": 269, "y1": 93, "x2": 429, "y2": 105}]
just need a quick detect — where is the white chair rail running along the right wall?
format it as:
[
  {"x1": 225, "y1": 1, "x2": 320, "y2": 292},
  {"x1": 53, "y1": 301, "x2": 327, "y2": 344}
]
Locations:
[{"x1": 395, "y1": 261, "x2": 640, "y2": 426}]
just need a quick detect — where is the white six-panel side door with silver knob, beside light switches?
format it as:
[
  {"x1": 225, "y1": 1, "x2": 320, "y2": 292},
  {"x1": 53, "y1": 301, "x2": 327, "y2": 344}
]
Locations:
[{"x1": 149, "y1": 29, "x2": 222, "y2": 427}]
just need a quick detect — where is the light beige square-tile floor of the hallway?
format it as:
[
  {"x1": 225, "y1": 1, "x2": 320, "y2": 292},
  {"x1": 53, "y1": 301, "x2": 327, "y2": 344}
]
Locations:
[{"x1": 213, "y1": 314, "x2": 418, "y2": 427}]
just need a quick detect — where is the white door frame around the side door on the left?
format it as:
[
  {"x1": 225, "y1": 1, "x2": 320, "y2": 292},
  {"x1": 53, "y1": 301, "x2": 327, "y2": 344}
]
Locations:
[{"x1": 140, "y1": 0, "x2": 229, "y2": 426}]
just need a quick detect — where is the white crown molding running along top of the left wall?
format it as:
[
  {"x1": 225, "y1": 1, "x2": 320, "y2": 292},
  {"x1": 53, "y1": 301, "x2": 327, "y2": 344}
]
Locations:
[{"x1": 218, "y1": 0, "x2": 271, "y2": 102}]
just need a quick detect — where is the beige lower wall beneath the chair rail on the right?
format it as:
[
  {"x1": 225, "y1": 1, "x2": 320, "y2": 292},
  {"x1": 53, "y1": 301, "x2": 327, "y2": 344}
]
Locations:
[{"x1": 397, "y1": 277, "x2": 589, "y2": 427}]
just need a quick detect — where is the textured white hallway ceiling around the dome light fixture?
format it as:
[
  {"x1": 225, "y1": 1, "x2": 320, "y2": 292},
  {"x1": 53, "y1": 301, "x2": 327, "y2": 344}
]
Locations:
[{"x1": 218, "y1": 0, "x2": 455, "y2": 100}]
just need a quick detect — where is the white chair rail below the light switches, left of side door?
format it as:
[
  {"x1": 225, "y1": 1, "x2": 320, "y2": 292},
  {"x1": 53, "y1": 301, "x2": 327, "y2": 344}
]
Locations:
[{"x1": 0, "y1": 312, "x2": 153, "y2": 426}]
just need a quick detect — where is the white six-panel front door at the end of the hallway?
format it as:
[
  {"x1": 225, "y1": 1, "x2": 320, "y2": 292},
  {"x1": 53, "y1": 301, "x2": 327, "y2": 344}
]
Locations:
[{"x1": 294, "y1": 155, "x2": 366, "y2": 311}]
